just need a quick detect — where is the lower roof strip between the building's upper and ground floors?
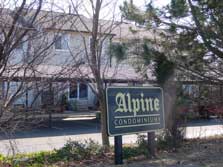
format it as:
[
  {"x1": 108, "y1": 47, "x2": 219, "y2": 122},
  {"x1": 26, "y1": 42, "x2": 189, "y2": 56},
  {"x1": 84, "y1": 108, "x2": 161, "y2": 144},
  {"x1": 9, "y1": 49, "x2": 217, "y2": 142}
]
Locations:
[{"x1": 3, "y1": 65, "x2": 155, "y2": 83}]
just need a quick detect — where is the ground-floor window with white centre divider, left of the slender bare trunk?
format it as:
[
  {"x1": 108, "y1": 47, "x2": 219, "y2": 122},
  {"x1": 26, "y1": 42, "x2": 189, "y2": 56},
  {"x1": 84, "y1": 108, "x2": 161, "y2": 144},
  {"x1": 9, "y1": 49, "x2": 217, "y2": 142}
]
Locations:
[{"x1": 69, "y1": 83, "x2": 88, "y2": 99}]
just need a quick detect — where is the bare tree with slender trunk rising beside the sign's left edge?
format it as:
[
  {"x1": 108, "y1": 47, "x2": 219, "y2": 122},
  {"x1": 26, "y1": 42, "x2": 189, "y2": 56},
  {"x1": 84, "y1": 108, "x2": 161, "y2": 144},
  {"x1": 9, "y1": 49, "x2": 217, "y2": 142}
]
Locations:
[{"x1": 62, "y1": 0, "x2": 120, "y2": 146}]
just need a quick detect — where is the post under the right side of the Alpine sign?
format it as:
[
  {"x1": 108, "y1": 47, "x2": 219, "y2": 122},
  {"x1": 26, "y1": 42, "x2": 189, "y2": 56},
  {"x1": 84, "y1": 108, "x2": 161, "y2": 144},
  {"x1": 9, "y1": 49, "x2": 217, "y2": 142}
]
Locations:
[{"x1": 147, "y1": 132, "x2": 156, "y2": 158}]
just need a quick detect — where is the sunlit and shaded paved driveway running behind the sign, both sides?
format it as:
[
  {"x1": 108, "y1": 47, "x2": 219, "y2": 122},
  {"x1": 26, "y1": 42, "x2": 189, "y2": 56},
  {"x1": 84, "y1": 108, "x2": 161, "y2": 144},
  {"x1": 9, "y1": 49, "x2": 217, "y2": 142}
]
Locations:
[{"x1": 0, "y1": 117, "x2": 223, "y2": 154}]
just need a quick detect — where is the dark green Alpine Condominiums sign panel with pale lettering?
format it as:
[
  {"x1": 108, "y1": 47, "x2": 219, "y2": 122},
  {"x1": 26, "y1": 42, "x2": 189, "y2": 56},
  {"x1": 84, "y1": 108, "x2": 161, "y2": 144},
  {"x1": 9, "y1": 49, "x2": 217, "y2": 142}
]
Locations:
[{"x1": 106, "y1": 87, "x2": 164, "y2": 136}]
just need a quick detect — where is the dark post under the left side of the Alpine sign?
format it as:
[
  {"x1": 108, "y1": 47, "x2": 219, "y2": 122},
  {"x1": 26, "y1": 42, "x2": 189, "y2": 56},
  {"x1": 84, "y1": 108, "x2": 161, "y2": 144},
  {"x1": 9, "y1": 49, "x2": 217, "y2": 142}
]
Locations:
[{"x1": 115, "y1": 136, "x2": 123, "y2": 165}]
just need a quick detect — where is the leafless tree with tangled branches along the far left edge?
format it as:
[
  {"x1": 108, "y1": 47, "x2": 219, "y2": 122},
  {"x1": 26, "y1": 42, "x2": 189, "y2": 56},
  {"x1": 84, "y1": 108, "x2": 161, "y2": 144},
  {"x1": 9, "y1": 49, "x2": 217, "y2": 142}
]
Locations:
[{"x1": 0, "y1": 0, "x2": 76, "y2": 136}]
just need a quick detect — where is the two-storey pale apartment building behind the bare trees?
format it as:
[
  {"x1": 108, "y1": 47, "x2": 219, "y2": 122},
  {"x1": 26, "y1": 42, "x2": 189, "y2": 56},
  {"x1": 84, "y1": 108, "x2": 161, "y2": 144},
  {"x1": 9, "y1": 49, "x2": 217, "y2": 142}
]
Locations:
[{"x1": 2, "y1": 8, "x2": 154, "y2": 110}]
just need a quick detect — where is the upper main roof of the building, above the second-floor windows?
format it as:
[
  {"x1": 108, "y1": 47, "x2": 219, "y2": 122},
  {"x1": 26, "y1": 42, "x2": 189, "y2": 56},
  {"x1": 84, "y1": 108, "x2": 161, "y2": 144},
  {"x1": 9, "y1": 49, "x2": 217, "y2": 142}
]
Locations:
[{"x1": 0, "y1": 8, "x2": 158, "y2": 38}]
